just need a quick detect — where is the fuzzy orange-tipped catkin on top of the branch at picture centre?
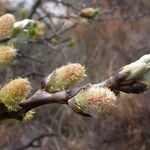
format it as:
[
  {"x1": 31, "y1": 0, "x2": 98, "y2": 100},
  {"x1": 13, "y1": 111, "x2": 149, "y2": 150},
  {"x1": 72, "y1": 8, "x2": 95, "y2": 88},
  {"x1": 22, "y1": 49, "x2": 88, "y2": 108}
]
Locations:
[{"x1": 44, "y1": 63, "x2": 86, "y2": 92}]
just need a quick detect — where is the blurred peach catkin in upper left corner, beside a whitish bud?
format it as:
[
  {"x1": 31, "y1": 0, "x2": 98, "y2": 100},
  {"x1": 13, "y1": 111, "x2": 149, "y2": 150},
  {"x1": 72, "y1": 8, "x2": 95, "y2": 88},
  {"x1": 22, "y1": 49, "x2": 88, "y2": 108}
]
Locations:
[{"x1": 0, "y1": 14, "x2": 15, "y2": 38}]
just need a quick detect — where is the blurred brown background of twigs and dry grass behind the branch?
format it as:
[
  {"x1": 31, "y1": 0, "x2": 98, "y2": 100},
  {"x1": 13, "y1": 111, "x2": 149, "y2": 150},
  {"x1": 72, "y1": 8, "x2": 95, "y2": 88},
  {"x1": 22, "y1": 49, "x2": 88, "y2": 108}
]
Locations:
[{"x1": 0, "y1": 0, "x2": 150, "y2": 150}]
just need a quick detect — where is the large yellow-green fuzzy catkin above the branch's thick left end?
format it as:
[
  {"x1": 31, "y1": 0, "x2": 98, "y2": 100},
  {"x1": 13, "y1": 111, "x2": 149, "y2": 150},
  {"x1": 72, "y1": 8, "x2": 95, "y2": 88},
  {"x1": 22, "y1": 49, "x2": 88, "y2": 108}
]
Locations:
[{"x1": 0, "y1": 77, "x2": 31, "y2": 111}]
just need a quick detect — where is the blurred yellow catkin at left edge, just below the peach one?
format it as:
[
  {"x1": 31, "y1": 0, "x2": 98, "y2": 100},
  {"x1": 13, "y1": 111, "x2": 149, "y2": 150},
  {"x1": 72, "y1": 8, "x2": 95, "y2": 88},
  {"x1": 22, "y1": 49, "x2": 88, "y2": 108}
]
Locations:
[{"x1": 0, "y1": 45, "x2": 16, "y2": 69}]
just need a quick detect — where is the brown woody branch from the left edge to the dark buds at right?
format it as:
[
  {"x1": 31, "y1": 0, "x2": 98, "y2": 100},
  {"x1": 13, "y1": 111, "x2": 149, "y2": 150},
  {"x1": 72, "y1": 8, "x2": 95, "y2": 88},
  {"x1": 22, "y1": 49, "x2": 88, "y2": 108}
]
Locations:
[{"x1": 0, "y1": 73, "x2": 147, "y2": 121}]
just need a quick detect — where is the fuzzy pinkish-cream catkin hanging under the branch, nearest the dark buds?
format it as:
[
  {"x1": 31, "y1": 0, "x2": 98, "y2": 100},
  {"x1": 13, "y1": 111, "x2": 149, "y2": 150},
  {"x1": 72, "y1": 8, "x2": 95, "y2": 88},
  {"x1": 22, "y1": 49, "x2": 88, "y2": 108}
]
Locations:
[{"x1": 68, "y1": 87, "x2": 117, "y2": 115}]
